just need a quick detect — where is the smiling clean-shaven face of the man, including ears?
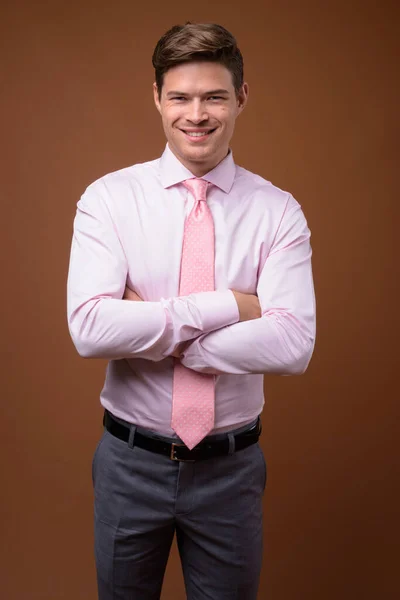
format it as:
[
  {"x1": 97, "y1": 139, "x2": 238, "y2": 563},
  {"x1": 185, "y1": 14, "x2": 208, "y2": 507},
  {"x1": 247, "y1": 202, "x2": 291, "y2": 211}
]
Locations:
[{"x1": 153, "y1": 62, "x2": 248, "y2": 177}]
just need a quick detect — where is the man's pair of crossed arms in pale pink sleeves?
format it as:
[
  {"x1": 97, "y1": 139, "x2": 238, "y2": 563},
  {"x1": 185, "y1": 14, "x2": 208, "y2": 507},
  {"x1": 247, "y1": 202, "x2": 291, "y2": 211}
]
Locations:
[{"x1": 68, "y1": 190, "x2": 315, "y2": 374}]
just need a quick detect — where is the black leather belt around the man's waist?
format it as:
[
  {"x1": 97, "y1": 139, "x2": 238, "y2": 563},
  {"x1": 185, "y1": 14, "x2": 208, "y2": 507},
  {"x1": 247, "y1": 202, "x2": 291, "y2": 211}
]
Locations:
[{"x1": 103, "y1": 410, "x2": 261, "y2": 462}]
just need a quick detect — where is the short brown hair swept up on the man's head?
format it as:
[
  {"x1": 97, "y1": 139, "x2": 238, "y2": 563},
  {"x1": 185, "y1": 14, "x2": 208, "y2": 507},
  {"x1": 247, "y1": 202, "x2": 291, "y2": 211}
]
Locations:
[{"x1": 152, "y1": 22, "x2": 243, "y2": 96}]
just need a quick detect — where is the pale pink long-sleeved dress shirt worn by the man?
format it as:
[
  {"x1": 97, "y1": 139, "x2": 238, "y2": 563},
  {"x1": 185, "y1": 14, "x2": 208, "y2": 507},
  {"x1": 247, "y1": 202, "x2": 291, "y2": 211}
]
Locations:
[{"x1": 68, "y1": 145, "x2": 315, "y2": 436}]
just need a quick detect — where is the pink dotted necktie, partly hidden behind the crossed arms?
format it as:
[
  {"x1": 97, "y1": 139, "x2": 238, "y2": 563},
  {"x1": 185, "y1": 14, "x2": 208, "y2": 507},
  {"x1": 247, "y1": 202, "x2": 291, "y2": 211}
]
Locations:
[{"x1": 171, "y1": 179, "x2": 215, "y2": 449}]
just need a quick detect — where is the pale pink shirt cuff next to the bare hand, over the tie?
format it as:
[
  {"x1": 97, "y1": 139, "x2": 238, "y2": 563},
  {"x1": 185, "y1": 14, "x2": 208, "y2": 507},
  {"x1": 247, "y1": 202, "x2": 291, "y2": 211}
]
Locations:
[{"x1": 193, "y1": 290, "x2": 239, "y2": 332}]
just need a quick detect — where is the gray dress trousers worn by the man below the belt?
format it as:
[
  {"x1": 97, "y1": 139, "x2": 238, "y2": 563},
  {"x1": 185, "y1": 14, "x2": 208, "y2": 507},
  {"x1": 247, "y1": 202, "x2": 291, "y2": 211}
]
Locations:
[{"x1": 93, "y1": 420, "x2": 266, "y2": 600}]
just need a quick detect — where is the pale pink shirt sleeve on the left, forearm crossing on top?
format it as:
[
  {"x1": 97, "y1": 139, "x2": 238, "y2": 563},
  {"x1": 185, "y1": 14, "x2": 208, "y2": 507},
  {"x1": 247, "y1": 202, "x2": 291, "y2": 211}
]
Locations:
[{"x1": 67, "y1": 193, "x2": 239, "y2": 361}]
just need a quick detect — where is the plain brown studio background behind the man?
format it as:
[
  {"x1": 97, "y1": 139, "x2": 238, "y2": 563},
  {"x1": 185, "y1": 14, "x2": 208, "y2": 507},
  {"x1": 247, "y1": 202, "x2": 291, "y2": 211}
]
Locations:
[{"x1": 0, "y1": 0, "x2": 399, "y2": 600}]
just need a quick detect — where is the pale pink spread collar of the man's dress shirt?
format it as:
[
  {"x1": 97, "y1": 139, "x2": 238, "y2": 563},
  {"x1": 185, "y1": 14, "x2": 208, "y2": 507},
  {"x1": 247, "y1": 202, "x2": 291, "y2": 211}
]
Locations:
[{"x1": 160, "y1": 144, "x2": 236, "y2": 193}]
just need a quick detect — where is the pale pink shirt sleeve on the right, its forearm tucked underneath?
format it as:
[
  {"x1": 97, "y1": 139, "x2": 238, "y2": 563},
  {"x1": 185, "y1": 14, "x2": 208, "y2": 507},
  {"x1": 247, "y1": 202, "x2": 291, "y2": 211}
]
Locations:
[{"x1": 181, "y1": 196, "x2": 315, "y2": 375}]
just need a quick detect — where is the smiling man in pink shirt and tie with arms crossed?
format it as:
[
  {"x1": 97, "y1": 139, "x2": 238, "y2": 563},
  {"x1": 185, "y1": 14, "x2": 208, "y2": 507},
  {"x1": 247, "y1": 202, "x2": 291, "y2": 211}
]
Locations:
[{"x1": 68, "y1": 23, "x2": 315, "y2": 600}]
